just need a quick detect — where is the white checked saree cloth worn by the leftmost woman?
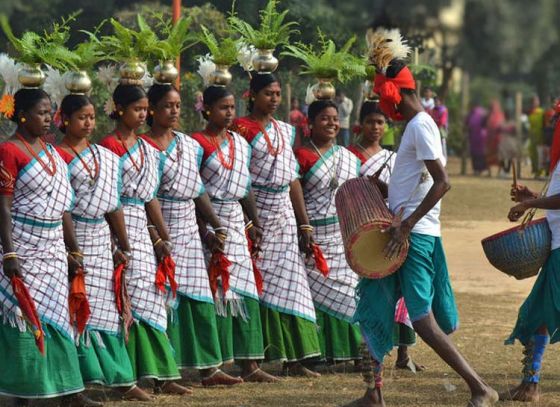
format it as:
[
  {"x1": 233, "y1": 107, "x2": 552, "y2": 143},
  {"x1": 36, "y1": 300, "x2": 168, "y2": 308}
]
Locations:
[{"x1": 0, "y1": 148, "x2": 74, "y2": 340}]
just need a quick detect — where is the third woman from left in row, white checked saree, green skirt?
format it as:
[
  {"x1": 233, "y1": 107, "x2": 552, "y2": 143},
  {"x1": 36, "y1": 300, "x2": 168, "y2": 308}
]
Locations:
[{"x1": 101, "y1": 85, "x2": 190, "y2": 394}]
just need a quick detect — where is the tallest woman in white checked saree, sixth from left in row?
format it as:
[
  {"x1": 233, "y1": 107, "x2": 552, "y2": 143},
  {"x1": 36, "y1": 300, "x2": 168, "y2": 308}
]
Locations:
[{"x1": 235, "y1": 74, "x2": 321, "y2": 376}]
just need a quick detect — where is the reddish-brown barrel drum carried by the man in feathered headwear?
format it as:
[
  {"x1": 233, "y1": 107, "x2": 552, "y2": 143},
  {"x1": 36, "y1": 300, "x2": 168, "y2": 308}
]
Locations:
[{"x1": 335, "y1": 178, "x2": 408, "y2": 279}]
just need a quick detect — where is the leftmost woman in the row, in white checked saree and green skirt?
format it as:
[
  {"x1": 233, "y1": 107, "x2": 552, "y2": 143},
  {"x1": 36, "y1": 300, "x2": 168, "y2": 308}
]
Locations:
[{"x1": 0, "y1": 89, "x2": 98, "y2": 405}]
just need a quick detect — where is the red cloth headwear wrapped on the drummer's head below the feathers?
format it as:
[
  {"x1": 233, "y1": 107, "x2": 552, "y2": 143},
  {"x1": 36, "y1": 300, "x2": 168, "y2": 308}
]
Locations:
[{"x1": 373, "y1": 66, "x2": 416, "y2": 121}]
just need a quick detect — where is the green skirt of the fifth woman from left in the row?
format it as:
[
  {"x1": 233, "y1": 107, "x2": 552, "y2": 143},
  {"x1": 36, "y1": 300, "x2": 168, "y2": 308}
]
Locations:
[{"x1": 216, "y1": 297, "x2": 264, "y2": 362}]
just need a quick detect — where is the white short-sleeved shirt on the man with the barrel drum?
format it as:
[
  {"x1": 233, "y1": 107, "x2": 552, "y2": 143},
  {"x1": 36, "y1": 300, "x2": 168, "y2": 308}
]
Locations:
[{"x1": 389, "y1": 112, "x2": 446, "y2": 236}]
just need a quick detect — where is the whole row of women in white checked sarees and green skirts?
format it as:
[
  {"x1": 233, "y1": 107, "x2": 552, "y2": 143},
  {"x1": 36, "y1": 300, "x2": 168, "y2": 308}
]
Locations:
[{"x1": 0, "y1": 74, "x2": 418, "y2": 406}]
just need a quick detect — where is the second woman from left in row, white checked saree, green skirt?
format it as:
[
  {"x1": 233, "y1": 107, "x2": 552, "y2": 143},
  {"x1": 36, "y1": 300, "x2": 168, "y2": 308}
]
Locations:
[{"x1": 58, "y1": 95, "x2": 150, "y2": 401}]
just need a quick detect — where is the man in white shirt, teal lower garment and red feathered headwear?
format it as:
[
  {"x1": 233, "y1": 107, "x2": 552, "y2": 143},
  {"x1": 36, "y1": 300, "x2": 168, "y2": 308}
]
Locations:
[{"x1": 351, "y1": 29, "x2": 498, "y2": 407}]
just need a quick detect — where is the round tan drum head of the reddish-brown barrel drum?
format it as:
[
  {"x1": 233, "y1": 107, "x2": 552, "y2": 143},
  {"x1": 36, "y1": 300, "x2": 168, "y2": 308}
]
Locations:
[{"x1": 346, "y1": 222, "x2": 408, "y2": 279}]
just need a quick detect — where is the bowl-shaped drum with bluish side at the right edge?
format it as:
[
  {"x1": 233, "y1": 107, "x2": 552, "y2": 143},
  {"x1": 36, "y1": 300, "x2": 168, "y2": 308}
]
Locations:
[{"x1": 482, "y1": 218, "x2": 552, "y2": 280}]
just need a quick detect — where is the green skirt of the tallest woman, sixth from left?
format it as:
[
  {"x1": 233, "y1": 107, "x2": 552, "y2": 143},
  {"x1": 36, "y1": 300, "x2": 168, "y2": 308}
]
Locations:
[{"x1": 261, "y1": 305, "x2": 321, "y2": 362}]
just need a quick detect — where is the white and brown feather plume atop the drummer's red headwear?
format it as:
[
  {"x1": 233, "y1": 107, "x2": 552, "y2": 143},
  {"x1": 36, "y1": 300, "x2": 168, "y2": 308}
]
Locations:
[{"x1": 366, "y1": 27, "x2": 410, "y2": 74}]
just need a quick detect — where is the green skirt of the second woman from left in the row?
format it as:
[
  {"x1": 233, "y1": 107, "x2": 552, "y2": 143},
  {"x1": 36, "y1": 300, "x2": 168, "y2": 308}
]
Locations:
[{"x1": 78, "y1": 331, "x2": 136, "y2": 387}]
